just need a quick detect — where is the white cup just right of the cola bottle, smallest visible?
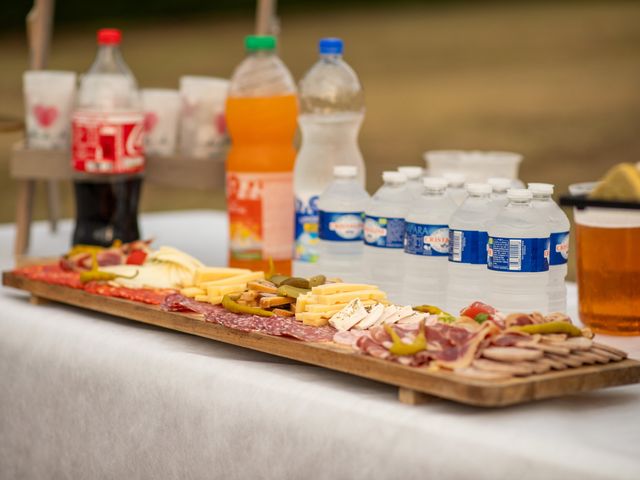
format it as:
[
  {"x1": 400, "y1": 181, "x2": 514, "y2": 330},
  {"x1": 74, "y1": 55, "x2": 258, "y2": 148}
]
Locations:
[{"x1": 142, "y1": 88, "x2": 180, "y2": 156}]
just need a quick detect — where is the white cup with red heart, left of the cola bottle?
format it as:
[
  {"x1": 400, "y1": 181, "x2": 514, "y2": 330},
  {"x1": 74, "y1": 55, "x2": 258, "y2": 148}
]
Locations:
[{"x1": 22, "y1": 70, "x2": 76, "y2": 150}]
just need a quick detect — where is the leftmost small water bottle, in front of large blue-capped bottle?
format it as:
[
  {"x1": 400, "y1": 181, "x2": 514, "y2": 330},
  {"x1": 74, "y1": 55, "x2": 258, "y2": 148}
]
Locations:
[{"x1": 316, "y1": 165, "x2": 370, "y2": 283}]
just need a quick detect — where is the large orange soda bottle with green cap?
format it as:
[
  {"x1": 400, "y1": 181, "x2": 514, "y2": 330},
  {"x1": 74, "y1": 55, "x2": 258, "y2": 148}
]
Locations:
[{"x1": 226, "y1": 35, "x2": 298, "y2": 274}]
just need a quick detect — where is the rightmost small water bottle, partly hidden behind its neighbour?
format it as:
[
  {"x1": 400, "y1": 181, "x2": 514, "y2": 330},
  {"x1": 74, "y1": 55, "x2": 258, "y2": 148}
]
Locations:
[{"x1": 529, "y1": 183, "x2": 571, "y2": 313}]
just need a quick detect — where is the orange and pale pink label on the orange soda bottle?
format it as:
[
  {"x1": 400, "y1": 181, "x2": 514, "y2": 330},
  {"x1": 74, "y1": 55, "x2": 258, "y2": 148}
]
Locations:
[{"x1": 227, "y1": 172, "x2": 294, "y2": 260}]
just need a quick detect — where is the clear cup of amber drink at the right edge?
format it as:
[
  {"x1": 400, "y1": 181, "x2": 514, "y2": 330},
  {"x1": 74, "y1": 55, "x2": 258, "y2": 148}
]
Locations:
[{"x1": 569, "y1": 183, "x2": 640, "y2": 335}]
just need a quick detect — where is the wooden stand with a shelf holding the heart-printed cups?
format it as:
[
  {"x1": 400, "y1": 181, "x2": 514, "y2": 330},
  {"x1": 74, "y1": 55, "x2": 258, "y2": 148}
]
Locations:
[{"x1": 9, "y1": 143, "x2": 226, "y2": 258}]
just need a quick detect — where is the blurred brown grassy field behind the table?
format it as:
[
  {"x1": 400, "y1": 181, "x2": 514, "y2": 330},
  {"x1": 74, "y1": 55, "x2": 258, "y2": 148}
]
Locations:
[{"x1": 0, "y1": 0, "x2": 640, "y2": 232}]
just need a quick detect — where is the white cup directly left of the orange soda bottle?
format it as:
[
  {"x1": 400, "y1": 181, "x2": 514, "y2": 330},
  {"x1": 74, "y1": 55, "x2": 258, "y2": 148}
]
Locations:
[{"x1": 180, "y1": 76, "x2": 229, "y2": 158}]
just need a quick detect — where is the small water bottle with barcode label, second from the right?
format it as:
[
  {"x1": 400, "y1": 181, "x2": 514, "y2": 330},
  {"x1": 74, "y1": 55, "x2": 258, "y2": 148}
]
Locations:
[{"x1": 487, "y1": 188, "x2": 549, "y2": 313}]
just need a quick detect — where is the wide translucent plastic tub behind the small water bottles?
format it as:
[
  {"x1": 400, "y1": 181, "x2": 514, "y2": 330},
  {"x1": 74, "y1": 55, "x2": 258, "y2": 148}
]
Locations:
[{"x1": 424, "y1": 150, "x2": 522, "y2": 183}]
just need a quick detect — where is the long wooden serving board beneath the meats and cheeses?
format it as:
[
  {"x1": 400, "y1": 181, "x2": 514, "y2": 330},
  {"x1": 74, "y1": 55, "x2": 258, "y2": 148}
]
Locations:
[{"x1": 2, "y1": 272, "x2": 640, "y2": 407}]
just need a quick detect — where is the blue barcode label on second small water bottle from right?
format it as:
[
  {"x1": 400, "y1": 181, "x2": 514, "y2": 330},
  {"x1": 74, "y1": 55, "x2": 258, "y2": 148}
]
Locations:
[{"x1": 487, "y1": 237, "x2": 549, "y2": 272}]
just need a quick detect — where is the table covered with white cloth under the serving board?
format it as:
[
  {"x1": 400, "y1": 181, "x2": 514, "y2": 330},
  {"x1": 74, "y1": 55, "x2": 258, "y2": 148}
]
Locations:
[{"x1": 0, "y1": 211, "x2": 640, "y2": 480}]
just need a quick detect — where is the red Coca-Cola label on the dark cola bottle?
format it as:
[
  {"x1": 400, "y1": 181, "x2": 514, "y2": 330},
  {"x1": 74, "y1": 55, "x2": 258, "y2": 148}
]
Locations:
[{"x1": 71, "y1": 111, "x2": 144, "y2": 174}]
